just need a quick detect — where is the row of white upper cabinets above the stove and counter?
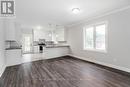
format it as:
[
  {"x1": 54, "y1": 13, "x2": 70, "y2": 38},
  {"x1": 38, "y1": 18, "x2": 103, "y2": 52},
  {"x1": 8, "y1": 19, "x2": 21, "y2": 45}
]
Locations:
[{"x1": 34, "y1": 28, "x2": 65, "y2": 42}]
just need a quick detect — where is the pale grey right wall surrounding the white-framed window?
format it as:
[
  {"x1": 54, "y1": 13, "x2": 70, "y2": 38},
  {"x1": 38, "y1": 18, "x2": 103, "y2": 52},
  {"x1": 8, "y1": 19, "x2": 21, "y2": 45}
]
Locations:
[{"x1": 68, "y1": 8, "x2": 130, "y2": 69}]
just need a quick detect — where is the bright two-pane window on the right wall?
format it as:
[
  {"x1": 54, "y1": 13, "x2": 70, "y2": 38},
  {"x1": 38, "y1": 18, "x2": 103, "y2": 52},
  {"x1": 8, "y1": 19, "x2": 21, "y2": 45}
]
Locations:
[{"x1": 84, "y1": 23, "x2": 106, "y2": 51}]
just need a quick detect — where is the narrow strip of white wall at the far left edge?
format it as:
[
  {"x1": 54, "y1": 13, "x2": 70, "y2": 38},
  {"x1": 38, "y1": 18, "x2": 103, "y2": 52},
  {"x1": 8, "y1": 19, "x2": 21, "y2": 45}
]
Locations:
[{"x1": 0, "y1": 20, "x2": 5, "y2": 77}]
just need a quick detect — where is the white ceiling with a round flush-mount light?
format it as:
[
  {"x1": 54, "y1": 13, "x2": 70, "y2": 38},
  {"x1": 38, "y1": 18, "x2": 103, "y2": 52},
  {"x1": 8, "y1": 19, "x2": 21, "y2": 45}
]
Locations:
[{"x1": 15, "y1": 0, "x2": 130, "y2": 25}]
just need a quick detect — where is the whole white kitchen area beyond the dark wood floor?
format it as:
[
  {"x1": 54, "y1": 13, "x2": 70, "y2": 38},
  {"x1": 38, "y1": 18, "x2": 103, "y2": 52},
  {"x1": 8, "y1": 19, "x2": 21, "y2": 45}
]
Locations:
[{"x1": 5, "y1": 19, "x2": 69, "y2": 66}]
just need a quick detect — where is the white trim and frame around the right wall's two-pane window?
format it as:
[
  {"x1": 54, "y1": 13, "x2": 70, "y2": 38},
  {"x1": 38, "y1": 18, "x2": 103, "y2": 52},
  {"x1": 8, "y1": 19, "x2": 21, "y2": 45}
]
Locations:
[{"x1": 83, "y1": 21, "x2": 108, "y2": 53}]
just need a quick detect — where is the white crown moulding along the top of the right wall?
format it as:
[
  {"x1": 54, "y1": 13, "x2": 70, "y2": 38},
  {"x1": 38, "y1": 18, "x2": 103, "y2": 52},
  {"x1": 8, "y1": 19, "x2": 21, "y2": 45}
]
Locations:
[{"x1": 66, "y1": 5, "x2": 130, "y2": 27}]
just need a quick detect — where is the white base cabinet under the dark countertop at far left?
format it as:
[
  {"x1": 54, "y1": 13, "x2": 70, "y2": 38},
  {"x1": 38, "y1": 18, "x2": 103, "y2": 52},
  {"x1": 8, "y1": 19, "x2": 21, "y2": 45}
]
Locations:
[{"x1": 6, "y1": 49, "x2": 22, "y2": 66}]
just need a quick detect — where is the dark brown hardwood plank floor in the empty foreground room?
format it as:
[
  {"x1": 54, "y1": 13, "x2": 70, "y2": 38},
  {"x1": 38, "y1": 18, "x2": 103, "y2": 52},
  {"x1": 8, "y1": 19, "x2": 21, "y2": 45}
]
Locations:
[{"x1": 0, "y1": 56, "x2": 130, "y2": 87}]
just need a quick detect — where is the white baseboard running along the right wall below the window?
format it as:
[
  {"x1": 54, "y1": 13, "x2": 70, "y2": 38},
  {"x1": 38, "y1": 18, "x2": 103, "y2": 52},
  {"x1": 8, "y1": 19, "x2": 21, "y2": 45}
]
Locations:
[{"x1": 68, "y1": 54, "x2": 130, "y2": 73}]
